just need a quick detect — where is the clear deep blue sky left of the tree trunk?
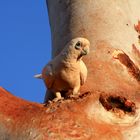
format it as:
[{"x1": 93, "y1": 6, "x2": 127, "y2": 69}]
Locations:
[{"x1": 0, "y1": 0, "x2": 51, "y2": 102}]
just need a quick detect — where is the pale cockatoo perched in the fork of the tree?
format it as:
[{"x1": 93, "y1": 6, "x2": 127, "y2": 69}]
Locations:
[{"x1": 35, "y1": 37, "x2": 90, "y2": 102}]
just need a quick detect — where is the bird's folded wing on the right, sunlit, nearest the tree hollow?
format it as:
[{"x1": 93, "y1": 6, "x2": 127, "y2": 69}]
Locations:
[{"x1": 80, "y1": 60, "x2": 87, "y2": 85}]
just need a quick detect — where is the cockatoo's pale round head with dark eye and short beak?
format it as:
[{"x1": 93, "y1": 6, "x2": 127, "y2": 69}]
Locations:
[{"x1": 69, "y1": 37, "x2": 90, "y2": 60}]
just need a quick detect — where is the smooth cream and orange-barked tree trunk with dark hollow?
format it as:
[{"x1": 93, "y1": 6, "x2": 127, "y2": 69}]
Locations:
[{"x1": 0, "y1": 0, "x2": 140, "y2": 140}]
